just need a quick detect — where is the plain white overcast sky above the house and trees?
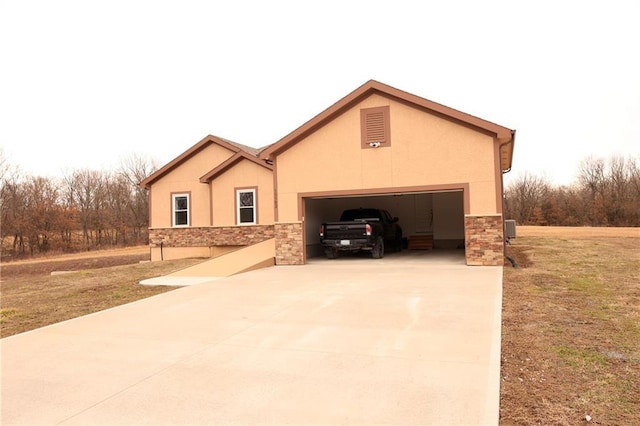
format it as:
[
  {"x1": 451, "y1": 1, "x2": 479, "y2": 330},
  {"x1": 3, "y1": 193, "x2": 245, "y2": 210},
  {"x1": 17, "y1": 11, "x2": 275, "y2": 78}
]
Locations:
[{"x1": 0, "y1": 0, "x2": 640, "y2": 184}]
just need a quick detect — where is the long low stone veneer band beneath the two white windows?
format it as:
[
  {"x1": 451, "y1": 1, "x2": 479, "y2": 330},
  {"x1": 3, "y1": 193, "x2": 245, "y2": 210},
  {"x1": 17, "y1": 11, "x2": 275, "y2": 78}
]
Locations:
[{"x1": 149, "y1": 225, "x2": 273, "y2": 247}]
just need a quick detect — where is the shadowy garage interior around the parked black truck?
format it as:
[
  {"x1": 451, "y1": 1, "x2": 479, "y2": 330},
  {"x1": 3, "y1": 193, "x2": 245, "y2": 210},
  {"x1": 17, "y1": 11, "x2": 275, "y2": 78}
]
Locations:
[{"x1": 303, "y1": 190, "x2": 464, "y2": 258}]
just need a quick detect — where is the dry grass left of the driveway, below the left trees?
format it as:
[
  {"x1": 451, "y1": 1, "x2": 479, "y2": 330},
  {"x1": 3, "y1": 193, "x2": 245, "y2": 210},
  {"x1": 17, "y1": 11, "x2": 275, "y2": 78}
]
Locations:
[{"x1": 0, "y1": 248, "x2": 202, "y2": 337}]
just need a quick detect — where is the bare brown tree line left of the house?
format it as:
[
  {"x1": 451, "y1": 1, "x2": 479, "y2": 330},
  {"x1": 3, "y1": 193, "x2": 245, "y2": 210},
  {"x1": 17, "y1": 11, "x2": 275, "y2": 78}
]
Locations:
[{"x1": 0, "y1": 152, "x2": 157, "y2": 257}]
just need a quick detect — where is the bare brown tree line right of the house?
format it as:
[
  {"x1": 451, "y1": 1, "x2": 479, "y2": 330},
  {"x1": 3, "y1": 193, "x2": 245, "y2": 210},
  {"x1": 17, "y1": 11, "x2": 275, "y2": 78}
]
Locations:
[{"x1": 504, "y1": 156, "x2": 640, "y2": 226}]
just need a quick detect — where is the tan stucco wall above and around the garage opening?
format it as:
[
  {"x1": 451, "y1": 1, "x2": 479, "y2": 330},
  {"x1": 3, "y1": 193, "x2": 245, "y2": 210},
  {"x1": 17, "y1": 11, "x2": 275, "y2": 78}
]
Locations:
[{"x1": 276, "y1": 94, "x2": 497, "y2": 221}]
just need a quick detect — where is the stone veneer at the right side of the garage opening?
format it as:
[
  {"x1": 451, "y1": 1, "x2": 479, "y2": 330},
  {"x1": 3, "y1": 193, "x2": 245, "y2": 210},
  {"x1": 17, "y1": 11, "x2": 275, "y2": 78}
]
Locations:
[{"x1": 464, "y1": 215, "x2": 504, "y2": 266}]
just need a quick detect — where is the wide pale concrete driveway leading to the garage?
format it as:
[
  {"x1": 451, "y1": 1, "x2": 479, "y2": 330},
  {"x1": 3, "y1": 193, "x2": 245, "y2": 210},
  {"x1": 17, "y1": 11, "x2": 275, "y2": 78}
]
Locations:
[{"x1": 1, "y1": 256, "x2": 502, "y2": 425}]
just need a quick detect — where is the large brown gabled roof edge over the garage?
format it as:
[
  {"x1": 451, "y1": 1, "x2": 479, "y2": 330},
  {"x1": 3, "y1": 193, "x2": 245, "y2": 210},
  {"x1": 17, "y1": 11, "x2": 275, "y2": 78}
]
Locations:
[{"x1": 260, "y1": 80, "x2": 515, "y2": 171}]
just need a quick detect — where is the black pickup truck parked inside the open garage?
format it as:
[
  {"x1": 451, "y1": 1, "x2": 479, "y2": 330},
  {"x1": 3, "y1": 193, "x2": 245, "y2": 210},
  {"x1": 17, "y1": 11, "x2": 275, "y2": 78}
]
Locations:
[{"x1": 320, "y1": 209, "x2": 402, "y2": 259}]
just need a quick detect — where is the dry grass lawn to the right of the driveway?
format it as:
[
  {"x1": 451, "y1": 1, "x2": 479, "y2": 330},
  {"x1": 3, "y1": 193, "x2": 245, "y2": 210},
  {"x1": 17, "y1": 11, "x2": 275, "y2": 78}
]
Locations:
[{"x1": 500, "y1": 227, "x2": 640, "y2": 425}]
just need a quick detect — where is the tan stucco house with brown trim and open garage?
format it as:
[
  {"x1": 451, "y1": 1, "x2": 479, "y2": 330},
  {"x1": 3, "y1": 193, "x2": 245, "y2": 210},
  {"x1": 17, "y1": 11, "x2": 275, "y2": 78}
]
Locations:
[{"x1": 141, "y1": 80, "x2": 515, "y2": 265}]
